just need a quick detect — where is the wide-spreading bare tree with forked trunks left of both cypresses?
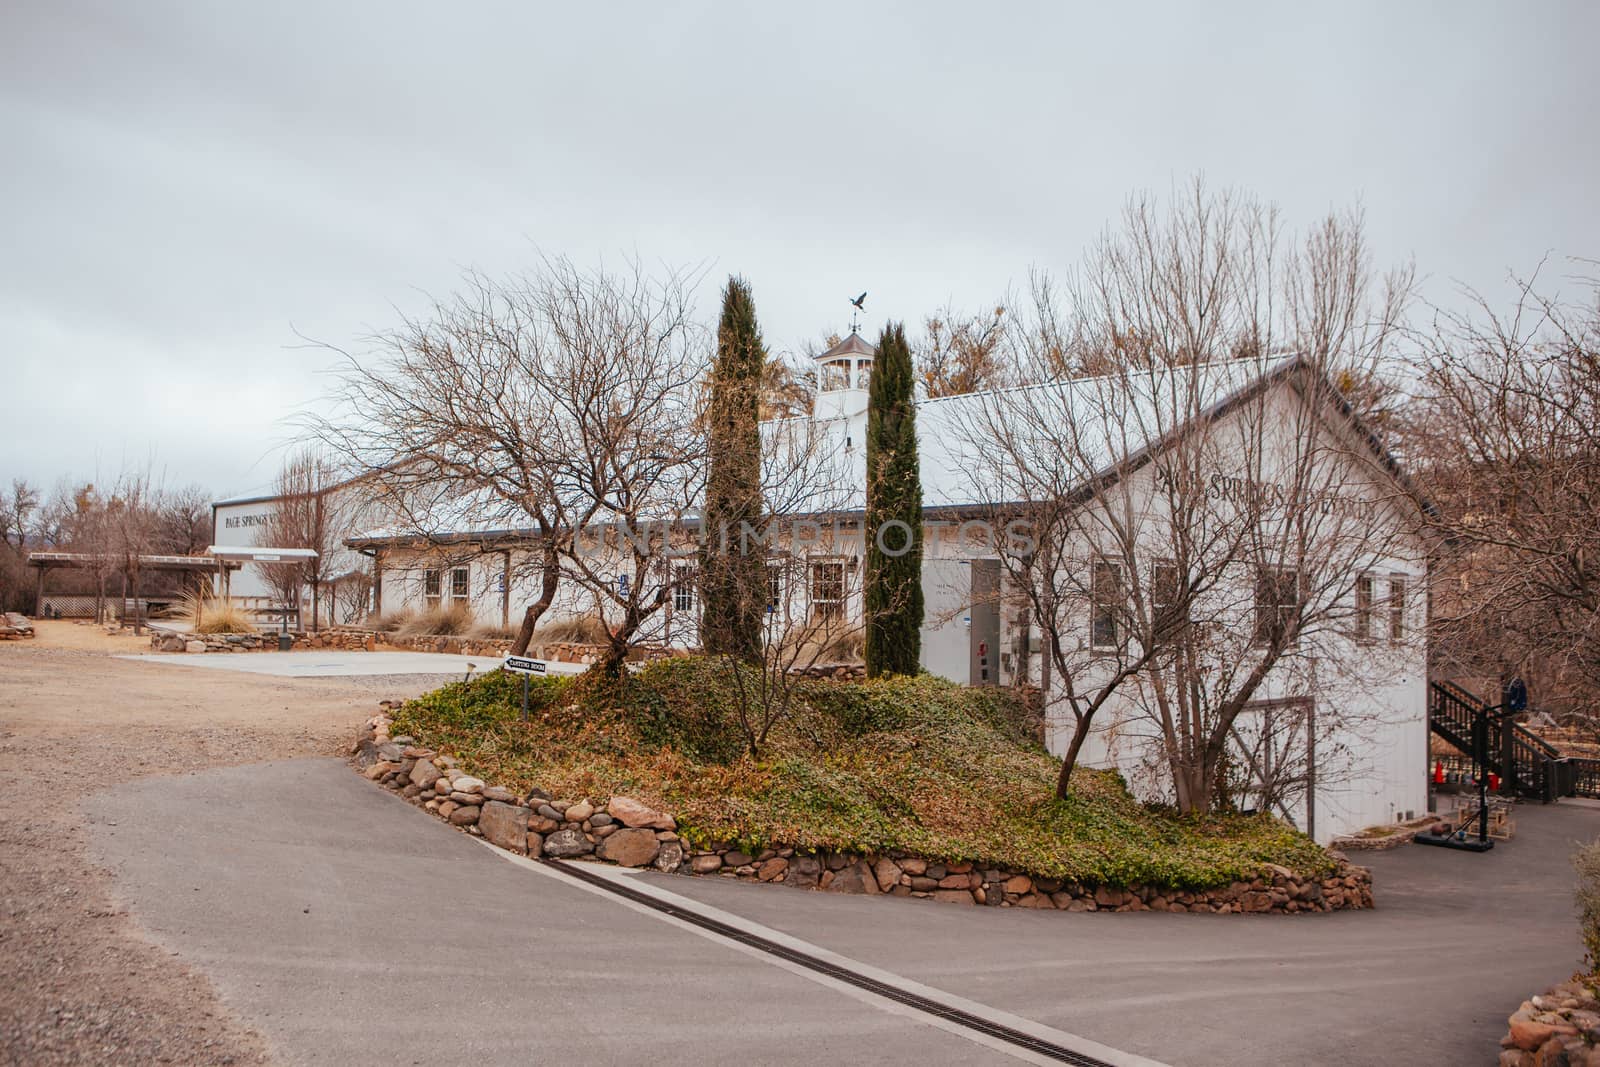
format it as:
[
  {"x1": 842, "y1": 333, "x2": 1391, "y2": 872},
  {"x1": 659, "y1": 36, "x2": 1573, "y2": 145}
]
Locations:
[{"x1": 312, "y1": 259, "x2": 706, "y2": 670}]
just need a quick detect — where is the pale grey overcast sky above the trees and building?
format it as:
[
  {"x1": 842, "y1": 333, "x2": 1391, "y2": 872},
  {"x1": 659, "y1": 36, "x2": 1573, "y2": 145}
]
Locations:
[{"x1": 0, "y1": 0, "x2": 1600, "y2": 494}]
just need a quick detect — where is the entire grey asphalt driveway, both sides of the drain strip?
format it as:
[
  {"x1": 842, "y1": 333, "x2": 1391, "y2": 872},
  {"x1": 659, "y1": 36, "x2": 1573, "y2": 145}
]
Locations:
[{"x1": 86, "y1": 760, "x2": 1600, "y2": 1065}]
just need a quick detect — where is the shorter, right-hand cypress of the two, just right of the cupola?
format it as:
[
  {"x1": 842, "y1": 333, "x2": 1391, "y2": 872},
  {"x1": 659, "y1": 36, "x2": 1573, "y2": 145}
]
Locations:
[{"x1": 864, "y1": 323, "x2": 923, "y2": 677}]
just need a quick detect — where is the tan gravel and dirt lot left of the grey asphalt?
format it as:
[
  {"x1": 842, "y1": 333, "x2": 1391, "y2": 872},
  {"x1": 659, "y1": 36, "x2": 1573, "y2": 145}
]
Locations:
[{"x1": 0, "y1": 643, "x2": 460, "y2": 1064}]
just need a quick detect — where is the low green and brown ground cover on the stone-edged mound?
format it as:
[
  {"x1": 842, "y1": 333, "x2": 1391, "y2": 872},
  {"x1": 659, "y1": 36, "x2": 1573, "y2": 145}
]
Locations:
[{"x1": 394, "y1": 657, "x2": 1333, "y2": 889}]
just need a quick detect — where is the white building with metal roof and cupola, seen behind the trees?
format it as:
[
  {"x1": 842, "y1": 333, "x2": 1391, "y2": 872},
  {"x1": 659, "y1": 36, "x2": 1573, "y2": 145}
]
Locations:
[{"x1": 216, "y1": 334, "x2": 1427, "y2": 841}]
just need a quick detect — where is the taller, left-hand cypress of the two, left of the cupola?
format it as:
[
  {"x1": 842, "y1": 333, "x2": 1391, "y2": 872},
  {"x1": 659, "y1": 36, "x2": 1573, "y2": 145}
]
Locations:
[{"x1": 701, "y1": 278, "x2": 766, "y2": 659}]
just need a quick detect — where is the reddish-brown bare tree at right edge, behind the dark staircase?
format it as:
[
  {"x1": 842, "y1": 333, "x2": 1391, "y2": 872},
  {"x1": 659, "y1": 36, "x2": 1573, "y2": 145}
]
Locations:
[{"x1": 1405, "y1": 261, "x2": 1600, "y2": 709}]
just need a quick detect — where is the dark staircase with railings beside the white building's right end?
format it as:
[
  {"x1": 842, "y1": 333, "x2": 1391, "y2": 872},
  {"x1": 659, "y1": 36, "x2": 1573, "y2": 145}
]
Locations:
[{"x1": 1427, "y1": 681, "x2": 1600, "y2": 803}]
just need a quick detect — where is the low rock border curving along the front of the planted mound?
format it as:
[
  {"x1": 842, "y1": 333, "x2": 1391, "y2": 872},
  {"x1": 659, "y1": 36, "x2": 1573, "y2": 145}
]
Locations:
[{"x1": 350, "y1": 701, "x2": 1373, "y2": 913}]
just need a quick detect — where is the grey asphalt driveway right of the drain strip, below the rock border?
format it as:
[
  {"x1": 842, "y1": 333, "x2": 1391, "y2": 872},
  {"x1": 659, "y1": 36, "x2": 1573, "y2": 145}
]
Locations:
[{"x1": 643, "y1": 801, "x2": 1600, "y2": 1067}]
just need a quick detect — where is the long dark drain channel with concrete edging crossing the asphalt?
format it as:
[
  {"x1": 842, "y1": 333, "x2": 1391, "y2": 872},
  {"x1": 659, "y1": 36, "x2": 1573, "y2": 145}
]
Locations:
[{"x1": 539, "y1": 857, "x2": 1114, "y2": 1067}]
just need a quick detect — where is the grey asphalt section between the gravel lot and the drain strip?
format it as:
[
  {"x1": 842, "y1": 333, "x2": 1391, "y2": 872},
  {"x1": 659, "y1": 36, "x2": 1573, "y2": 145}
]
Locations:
[{"x1": 86, "y1": 760, "x2": 1036, "y2": 1065}]
